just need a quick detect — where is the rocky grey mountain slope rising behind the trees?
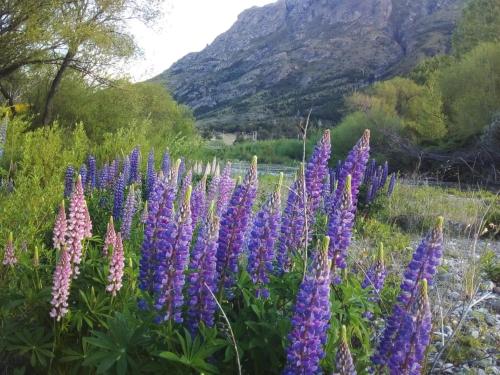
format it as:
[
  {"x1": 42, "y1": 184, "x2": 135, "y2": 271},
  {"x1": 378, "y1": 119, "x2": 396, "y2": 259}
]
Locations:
[{"x1": 153, "y1": 0, "x2": 465, "y2": 138}]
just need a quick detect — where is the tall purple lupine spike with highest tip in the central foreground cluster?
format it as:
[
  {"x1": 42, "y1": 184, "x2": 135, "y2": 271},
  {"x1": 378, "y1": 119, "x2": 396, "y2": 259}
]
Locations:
[{"x1": 217, "y1": 156, "x2": 258, "y2": 298}]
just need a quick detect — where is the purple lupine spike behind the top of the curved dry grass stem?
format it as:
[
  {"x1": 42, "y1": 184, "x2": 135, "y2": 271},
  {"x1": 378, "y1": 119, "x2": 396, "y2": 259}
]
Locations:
[{"x1": 187, "y1": 201, "x2": 220, "y2": 334}]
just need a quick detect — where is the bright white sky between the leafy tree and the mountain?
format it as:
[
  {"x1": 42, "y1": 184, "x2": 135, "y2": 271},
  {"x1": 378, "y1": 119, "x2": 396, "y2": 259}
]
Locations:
[{"x1": 127, "y1": 0, "x2": 274, "y2": 81}]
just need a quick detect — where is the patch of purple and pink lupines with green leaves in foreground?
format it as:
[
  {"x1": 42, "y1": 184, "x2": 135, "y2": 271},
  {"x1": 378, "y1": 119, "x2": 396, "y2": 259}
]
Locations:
[{"x1": 0, "y1": 119, "x2": 496, "y2": 374}]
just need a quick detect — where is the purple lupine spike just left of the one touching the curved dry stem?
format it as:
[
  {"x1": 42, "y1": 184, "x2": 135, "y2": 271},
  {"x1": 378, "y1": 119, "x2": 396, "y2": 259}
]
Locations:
[{"x1": 155, "y1": 186, "x2": 193, "y2": 323}]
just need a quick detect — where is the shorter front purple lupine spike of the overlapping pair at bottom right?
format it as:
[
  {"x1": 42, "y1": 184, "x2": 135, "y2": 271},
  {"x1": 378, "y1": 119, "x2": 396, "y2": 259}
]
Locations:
[{"x1": 388, "y1": 279, "x2": 432, "y2": 375}]
